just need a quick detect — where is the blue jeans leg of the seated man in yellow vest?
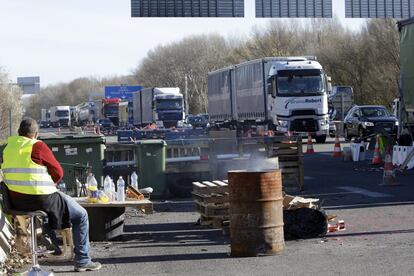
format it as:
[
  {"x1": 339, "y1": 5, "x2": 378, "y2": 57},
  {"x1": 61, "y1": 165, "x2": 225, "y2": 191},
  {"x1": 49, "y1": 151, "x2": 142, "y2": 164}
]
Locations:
[{"x1": 59, "y1": 192, "x2": 91, "y2": 266}]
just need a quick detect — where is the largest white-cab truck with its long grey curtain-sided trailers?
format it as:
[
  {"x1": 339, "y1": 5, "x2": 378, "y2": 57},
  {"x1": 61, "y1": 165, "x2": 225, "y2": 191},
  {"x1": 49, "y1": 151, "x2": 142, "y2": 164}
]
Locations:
[{"x1": 208, "y1": 57, "x2": 331, "y2": 143}]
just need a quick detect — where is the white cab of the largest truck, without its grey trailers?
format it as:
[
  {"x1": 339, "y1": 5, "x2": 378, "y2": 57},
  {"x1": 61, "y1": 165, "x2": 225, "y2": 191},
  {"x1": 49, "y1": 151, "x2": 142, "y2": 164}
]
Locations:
[{"x1": 268, "y1": 58, "x2": 331, "y2": 143}]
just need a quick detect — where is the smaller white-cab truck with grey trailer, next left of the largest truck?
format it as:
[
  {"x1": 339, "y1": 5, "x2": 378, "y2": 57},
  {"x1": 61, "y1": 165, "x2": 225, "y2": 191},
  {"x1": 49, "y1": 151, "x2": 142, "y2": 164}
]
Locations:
[{"x1": 133, "y1": 87, "x2": 185, "y2": 127}]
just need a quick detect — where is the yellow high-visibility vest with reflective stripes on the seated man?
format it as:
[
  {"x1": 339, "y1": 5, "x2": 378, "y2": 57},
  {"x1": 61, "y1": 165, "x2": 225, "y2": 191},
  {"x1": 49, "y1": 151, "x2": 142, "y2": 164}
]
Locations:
[{"x1": 1, "y1": 136, "x2": 57, "y2": 195}]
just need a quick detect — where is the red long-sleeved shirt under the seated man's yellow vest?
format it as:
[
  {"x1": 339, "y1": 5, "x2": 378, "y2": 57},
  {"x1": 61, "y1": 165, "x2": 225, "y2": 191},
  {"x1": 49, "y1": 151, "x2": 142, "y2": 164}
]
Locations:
[{"x1": 10, "y1": 141, "x2": 63, "y2": 197}]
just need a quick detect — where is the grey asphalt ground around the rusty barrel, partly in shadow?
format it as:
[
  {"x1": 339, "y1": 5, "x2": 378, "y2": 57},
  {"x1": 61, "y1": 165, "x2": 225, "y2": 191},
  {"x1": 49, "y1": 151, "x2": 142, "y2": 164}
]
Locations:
[{"x1": 38, "y1": 139, "x2": 414, "y2": 275}]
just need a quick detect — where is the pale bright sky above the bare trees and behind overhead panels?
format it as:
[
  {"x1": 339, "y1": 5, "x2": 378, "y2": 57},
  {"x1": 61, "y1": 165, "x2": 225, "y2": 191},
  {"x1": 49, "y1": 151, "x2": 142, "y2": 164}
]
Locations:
[{"x1": 0, "y1": 0, "x2": 363, "y2": 86}]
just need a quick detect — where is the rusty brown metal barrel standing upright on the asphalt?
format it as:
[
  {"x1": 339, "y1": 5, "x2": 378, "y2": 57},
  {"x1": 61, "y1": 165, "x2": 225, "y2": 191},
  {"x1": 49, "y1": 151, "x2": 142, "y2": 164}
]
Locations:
[{"x1": 228, "y1": 170, "x2": 285, "y2": 257}]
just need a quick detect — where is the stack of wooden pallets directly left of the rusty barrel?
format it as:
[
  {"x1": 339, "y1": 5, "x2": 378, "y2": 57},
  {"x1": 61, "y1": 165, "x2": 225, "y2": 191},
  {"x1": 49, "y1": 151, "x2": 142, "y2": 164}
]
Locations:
[{"x1": 192, "y1": 180, "x2": 229, "y2": 228}]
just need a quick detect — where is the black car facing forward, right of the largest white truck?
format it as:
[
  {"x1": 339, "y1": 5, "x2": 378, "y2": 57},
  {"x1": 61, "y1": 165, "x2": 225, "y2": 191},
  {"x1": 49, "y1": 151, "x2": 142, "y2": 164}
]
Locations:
[{"x1": 344, "y1": 105, "x2": 398, "y2": 140}]
